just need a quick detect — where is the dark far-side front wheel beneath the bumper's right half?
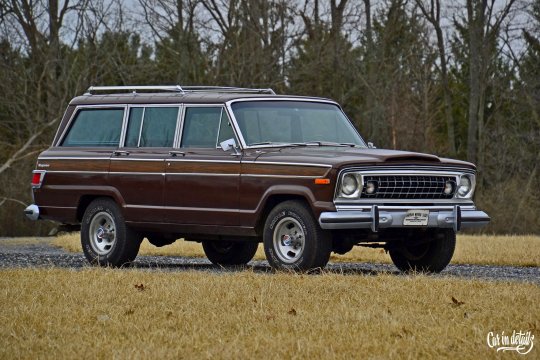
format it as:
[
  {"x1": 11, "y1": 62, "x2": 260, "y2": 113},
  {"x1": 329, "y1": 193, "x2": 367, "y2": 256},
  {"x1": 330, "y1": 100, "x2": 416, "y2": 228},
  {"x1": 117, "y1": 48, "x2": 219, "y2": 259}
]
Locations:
[{"x1": 389, "y1": 230, "x2": 456, "y2": 273}]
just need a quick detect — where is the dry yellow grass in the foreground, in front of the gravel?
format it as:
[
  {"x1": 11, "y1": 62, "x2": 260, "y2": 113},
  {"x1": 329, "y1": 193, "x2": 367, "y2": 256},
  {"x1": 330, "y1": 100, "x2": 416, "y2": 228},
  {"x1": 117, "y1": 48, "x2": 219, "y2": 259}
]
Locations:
[{"x1": 0, "y1": 268, "x2": 540, "y2": 359}]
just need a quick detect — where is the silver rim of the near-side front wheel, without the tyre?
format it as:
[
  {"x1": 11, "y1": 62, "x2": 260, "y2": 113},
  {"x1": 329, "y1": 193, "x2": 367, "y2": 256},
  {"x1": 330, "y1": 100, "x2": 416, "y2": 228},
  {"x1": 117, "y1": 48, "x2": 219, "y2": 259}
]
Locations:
[{"x1": 273, "y1": 217, "x2": 305, "y2": 264}]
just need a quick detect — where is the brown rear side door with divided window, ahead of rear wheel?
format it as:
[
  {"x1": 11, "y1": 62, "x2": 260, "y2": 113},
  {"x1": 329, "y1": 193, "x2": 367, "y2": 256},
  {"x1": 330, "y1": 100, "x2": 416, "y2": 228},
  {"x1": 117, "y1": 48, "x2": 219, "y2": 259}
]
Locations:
[{"x1": 109, "y1": 105, "x2": 181, "y2": 223}]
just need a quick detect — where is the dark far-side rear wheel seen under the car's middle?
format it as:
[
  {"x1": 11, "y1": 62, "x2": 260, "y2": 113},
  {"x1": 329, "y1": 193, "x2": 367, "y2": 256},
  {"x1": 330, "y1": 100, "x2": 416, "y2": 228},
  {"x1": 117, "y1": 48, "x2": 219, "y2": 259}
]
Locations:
[{"x1": 202, "y1": 241, "x2": 259, "y2": 266}]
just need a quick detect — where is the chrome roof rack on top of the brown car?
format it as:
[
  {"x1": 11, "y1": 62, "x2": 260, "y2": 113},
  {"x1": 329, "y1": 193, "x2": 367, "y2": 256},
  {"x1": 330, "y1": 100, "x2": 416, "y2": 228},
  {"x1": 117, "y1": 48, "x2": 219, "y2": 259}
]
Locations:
[{"x1": 85, "y1": 85, "x2": 276, "y2": 95}]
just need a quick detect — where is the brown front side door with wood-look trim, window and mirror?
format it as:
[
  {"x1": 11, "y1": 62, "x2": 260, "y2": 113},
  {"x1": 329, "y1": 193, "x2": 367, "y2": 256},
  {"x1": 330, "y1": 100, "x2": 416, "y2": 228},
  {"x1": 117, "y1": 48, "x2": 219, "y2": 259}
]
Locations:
[{"x1": 165, "y1": 105, "x2": 240, "y2": 226}]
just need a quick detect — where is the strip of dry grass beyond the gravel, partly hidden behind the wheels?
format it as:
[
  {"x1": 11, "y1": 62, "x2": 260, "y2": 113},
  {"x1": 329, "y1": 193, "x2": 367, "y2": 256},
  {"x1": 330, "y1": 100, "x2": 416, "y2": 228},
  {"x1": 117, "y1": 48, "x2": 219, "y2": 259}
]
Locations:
[{"x1": 53, "y1": 233, "x2": 540, "y2": 266}]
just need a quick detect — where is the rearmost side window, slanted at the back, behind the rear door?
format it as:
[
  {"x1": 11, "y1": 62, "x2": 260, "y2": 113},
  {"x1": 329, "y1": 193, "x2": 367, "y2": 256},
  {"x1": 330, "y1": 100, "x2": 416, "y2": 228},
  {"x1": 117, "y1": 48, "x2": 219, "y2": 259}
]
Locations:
[{"x1": 61, "y1": 109, "x2": 124, "y2": 147}]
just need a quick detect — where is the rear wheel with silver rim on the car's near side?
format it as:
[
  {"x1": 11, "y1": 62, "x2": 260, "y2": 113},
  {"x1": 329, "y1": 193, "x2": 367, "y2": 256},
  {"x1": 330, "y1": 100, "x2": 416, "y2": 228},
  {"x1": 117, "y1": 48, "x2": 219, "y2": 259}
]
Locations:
[{"x1": 81, "y1": 198, "x2": 142, "y2": 267}]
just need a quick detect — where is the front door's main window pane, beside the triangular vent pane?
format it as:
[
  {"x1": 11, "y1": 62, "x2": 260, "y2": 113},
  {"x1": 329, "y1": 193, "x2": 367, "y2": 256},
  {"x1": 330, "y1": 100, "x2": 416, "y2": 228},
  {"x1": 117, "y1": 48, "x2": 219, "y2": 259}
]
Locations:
[{"x1": 181, "y1": 106, "x2": 221, "y2": 148}]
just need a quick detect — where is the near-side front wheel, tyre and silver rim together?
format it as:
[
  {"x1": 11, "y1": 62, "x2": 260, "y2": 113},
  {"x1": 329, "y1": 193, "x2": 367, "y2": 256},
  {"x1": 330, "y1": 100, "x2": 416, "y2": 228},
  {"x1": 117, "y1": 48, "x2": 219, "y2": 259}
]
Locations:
[{"x1": 263, "y1": 200, "x2": 332, "y2": 271}]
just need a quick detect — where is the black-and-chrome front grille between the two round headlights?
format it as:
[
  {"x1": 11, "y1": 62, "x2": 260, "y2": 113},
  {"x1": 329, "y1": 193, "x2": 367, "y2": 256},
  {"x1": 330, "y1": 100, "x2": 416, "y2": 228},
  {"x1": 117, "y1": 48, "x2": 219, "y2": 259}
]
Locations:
[{"x1": 361, "y1": 175, "x2": 456, "y2": 199}]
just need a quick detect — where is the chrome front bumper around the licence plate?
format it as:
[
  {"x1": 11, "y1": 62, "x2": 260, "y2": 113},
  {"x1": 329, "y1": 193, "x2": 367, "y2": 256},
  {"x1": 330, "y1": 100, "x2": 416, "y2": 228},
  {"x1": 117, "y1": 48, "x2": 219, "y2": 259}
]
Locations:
[{"x1": 319, "y1": 205, "x2": 490, "y2": 232}]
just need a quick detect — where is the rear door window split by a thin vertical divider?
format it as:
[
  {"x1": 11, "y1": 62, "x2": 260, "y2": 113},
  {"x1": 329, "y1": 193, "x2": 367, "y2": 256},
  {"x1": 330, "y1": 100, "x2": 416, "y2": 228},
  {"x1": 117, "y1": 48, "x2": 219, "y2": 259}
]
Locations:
[{"x1": 125, "y1": 106, "x2": 178, "y2": 147}]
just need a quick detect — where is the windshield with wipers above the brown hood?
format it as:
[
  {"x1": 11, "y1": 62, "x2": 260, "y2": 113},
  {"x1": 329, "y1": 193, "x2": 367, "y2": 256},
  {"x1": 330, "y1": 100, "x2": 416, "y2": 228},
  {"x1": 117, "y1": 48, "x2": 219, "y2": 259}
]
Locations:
[{"x1": 231, "y1": 101, "x2": 365, "y2": 147}]
